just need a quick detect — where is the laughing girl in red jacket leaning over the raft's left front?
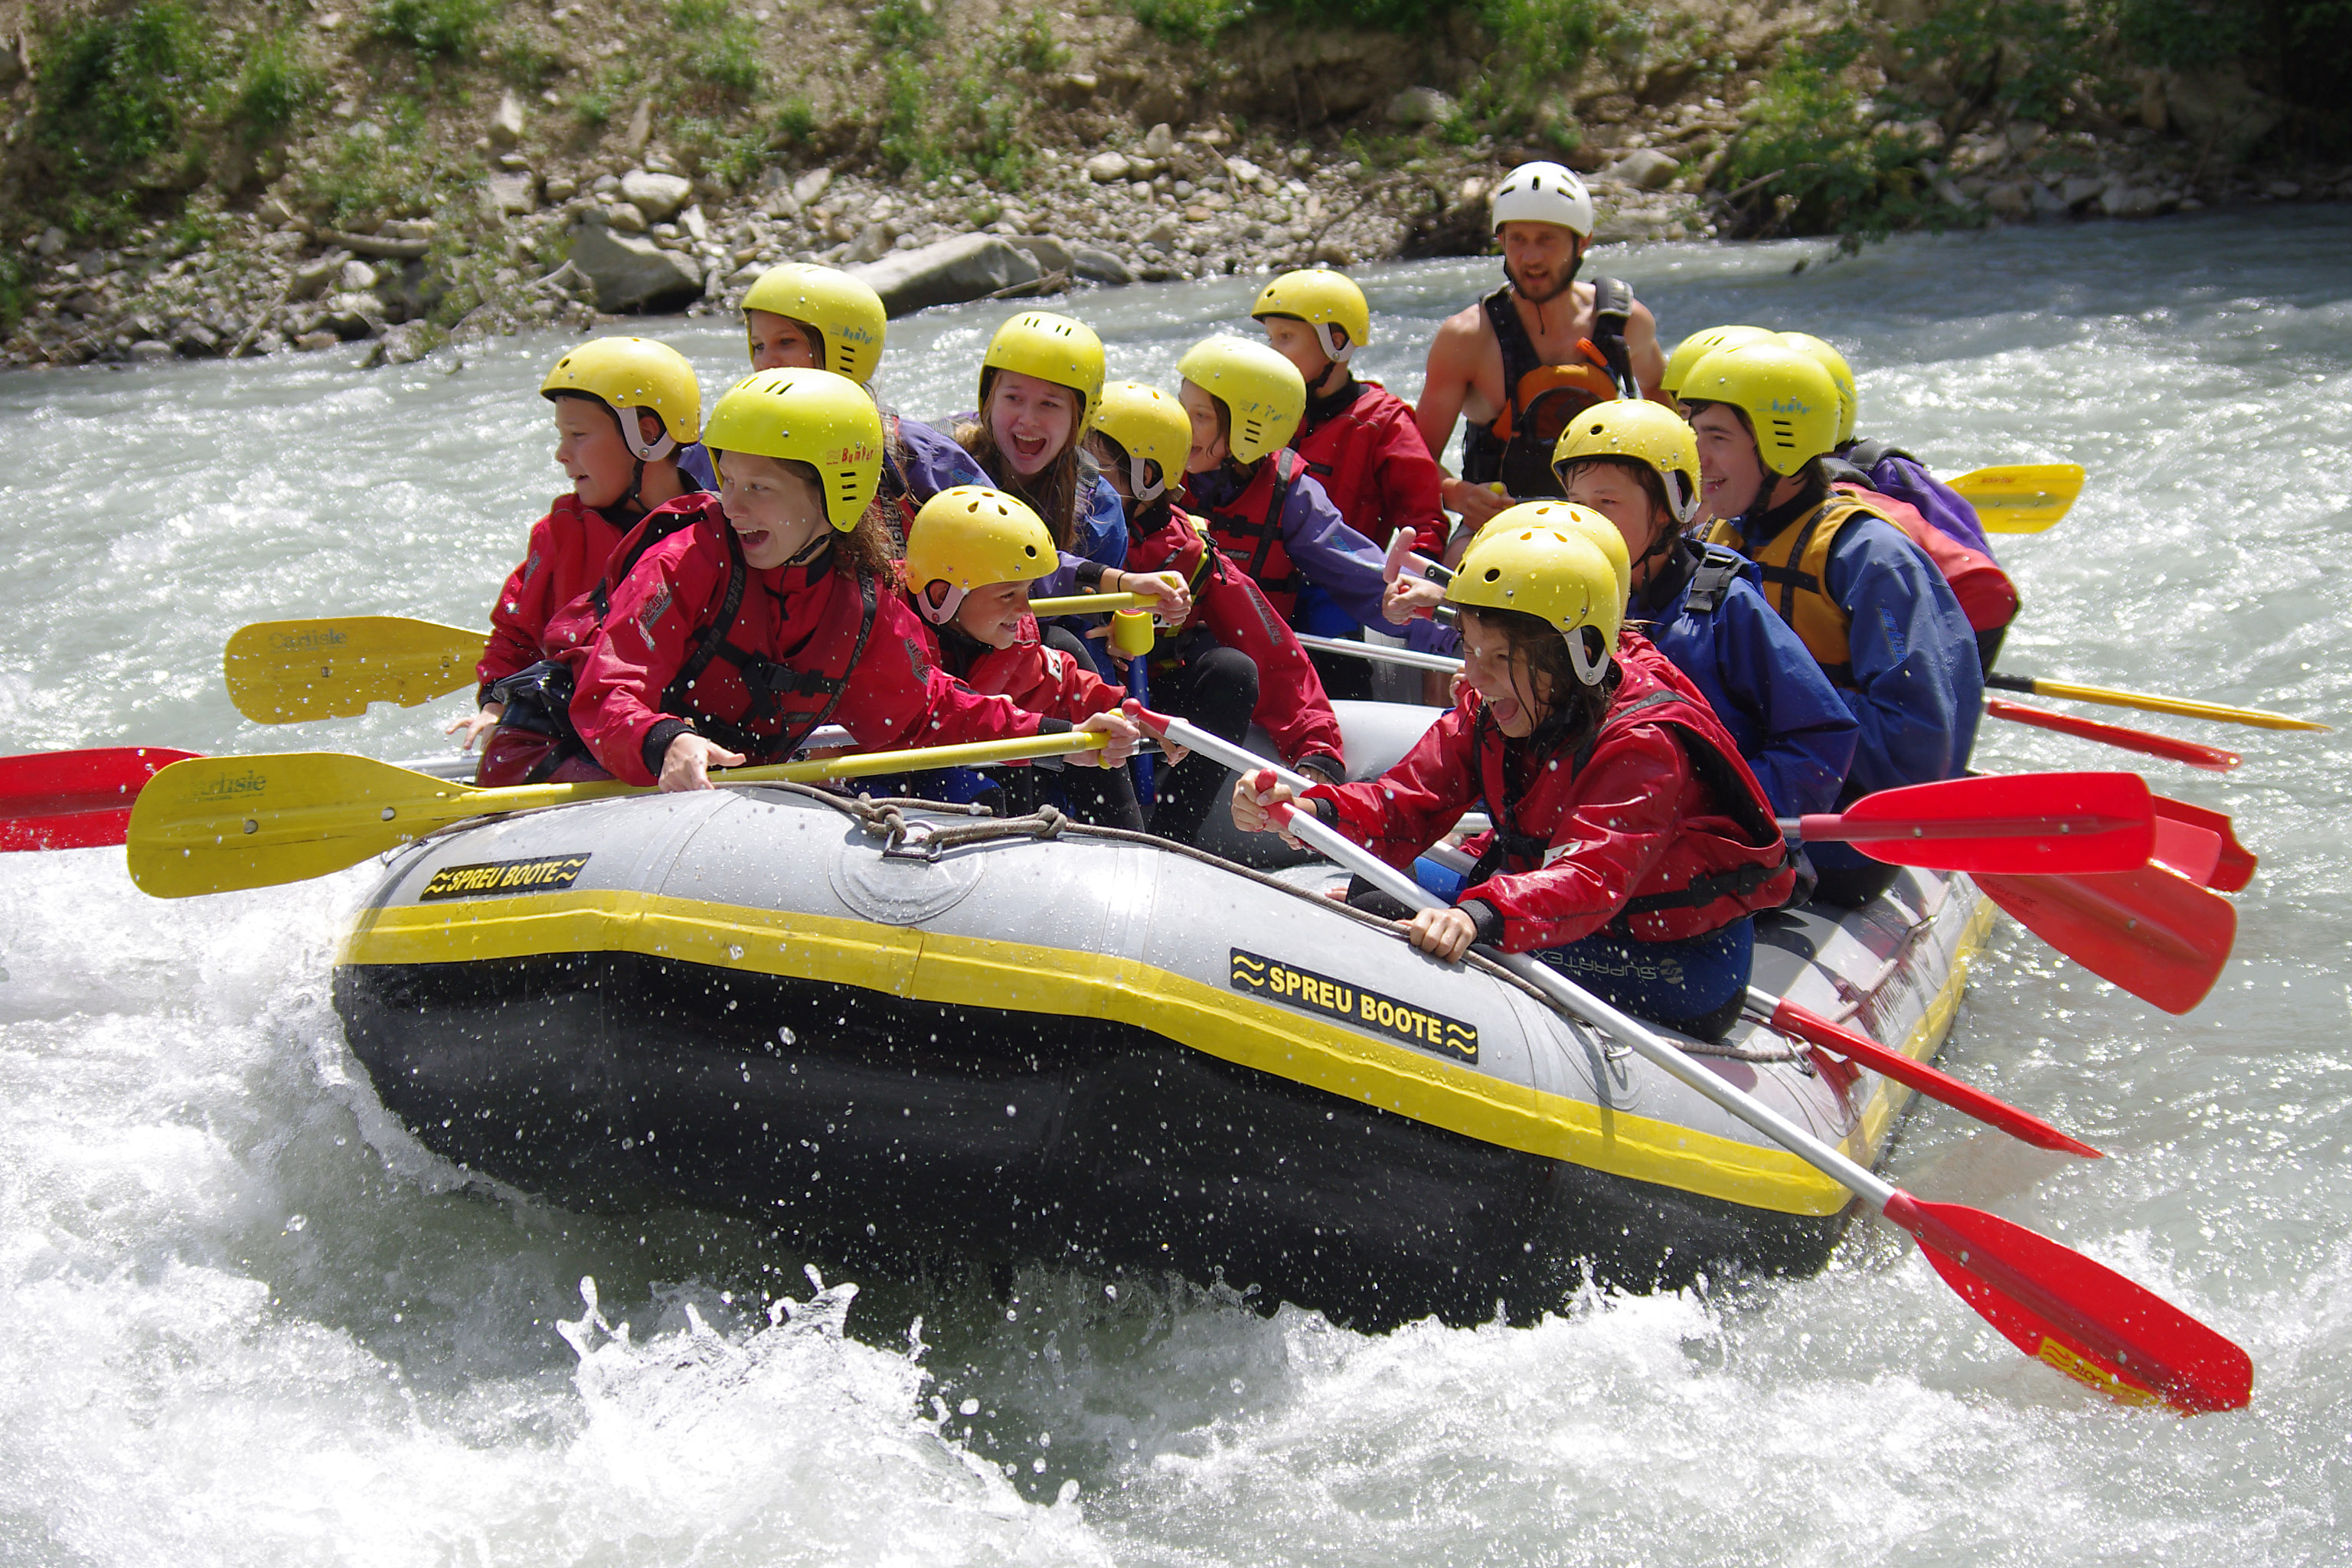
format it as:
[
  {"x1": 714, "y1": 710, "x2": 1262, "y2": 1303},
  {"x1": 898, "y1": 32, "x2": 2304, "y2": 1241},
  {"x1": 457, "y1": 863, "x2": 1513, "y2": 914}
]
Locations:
[{"x1": 571, "y1": 371, "x2": 1136, "y2": 790}]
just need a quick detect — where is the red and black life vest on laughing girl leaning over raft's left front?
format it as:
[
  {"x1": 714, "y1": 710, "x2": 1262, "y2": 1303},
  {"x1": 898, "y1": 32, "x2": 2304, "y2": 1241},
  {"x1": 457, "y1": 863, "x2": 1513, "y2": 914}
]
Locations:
[{"x1": 661, "y1": 524, "x2": 877, "y2": 764}]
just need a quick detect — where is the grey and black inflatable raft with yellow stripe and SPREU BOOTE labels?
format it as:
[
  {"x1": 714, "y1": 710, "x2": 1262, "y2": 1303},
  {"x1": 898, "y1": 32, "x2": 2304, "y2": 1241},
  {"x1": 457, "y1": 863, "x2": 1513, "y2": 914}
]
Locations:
[{"x1": 334, "y1": 705, "x2": 1990, "y2": 1328}]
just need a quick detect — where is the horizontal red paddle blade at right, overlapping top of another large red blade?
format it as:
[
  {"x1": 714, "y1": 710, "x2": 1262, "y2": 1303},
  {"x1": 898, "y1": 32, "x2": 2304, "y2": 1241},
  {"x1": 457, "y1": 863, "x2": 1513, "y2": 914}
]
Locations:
[{"x1": 1799, "y1": 773, "x2": 2157, "y2": 874}]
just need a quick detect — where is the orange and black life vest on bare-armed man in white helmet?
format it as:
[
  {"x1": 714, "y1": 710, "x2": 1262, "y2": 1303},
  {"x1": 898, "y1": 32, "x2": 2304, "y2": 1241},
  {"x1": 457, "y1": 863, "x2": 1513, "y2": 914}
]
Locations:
[{"x1": 1463, "y1": 277, "x2": 1642, "y2": 501}]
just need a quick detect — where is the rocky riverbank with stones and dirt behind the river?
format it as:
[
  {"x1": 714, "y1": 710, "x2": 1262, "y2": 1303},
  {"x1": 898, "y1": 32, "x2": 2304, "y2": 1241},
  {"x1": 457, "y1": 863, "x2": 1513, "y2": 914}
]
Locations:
[{"x1": 0, "y1": 0, "x2": 2352, "y2": 367}]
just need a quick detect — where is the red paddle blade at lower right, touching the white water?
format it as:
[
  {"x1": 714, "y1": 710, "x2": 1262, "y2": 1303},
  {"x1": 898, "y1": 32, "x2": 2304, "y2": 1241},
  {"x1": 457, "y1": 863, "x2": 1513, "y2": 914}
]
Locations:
[{"x1": 1886, "y1": 1192, "x2": 2253, "y2": 1415}]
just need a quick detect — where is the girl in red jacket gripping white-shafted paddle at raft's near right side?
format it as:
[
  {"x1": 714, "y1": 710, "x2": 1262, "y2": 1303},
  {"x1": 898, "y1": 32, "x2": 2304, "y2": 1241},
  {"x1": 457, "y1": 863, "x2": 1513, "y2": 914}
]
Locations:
[{"x1": 1233, "y1": 505, "x2": 1795, "y2": 1037}]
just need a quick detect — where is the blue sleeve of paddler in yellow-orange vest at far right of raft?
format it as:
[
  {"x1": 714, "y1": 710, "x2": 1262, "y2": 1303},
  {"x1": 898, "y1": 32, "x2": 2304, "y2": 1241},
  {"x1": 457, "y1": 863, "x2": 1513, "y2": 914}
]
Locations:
[{"x1": 1825, "y1": 518, "x2": 1985, "y2": 799}]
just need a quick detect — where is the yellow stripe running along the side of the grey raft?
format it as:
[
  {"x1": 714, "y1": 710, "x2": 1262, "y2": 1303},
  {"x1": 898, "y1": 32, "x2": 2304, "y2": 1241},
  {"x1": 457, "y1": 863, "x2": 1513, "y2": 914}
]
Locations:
[{"x1": 336, "y1": 889, "x2": 1990, "y2": 1215}]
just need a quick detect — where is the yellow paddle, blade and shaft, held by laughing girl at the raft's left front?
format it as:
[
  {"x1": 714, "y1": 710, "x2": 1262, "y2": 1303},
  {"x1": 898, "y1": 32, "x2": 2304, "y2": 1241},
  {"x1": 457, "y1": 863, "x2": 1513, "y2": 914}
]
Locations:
[{"x1": 125, "y1": 731, "x2": 1103, "y2": 898}]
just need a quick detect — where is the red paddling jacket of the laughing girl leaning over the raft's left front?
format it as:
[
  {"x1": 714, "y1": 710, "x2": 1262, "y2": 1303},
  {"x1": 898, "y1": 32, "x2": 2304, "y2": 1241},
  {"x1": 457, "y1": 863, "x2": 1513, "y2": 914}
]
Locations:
[{"x1": 567, "y1": 496, "x2": 1066, "y2": 786}]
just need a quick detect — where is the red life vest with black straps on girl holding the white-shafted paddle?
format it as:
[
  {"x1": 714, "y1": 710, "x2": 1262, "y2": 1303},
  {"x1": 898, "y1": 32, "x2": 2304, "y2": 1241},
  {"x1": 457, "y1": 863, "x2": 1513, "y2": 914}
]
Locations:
[{"x1": 1463, "y1": 639, "x2": 1795, "y2": 940}]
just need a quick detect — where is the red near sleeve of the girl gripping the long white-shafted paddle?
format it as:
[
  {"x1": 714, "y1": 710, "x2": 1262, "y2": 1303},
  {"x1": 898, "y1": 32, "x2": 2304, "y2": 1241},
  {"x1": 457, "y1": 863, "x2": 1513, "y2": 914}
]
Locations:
[{"x1": 1461, "y1": 724, "x2": 1691, "y2": 952}]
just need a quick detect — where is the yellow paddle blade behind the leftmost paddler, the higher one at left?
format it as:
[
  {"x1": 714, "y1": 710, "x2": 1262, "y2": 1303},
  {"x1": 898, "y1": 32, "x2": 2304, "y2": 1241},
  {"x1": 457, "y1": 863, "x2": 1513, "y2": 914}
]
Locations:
[{"x1": 221, "y1": 616, "x2": 487, "y2": 724}]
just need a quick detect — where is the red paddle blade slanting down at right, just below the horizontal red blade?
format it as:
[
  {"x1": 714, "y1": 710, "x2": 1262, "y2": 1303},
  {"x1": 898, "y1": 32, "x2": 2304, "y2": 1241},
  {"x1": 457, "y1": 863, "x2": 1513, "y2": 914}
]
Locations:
[{"x1": 1975, "y1": 865, "x2": 2236, "y2": 1013}]
